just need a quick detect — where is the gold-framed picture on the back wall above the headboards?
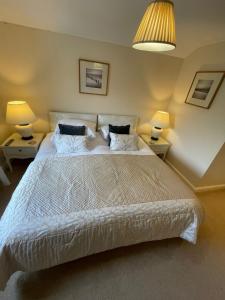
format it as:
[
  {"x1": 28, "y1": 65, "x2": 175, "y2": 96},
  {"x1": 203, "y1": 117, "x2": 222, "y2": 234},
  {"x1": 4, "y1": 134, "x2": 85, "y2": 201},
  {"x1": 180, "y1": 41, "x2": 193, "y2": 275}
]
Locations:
[{"x1": 79, "y1": 59, "x2": 109, "y2": 96}]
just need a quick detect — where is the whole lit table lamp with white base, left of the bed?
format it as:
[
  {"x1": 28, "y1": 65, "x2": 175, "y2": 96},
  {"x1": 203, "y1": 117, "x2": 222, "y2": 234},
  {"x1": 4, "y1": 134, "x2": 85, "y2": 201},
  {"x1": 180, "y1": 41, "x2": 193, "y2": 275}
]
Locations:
[{"x1": 6, "y1": 101, "x2": 36, "y2": 140}]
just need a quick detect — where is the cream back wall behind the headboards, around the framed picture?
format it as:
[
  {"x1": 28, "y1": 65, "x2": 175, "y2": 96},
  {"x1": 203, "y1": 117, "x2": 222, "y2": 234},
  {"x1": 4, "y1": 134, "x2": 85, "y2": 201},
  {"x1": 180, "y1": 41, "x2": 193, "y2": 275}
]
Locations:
[{"x1": 0, "y1": 23, "x2": 182, "y2": 144}]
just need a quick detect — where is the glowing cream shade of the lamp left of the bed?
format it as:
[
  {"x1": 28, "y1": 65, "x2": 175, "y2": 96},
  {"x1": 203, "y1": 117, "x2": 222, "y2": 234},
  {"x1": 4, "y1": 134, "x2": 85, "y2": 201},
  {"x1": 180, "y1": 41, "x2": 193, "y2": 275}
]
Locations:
[{"x1": 6, "y1": 101, "x2": 36, "y2": 125}]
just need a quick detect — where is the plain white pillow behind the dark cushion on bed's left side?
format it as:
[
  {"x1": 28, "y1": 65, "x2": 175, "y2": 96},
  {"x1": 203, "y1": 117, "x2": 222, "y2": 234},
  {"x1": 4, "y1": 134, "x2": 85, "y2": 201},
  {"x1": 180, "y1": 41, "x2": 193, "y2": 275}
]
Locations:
[{"x1": 54, "y1": 119, "x2": 96, "y2": 139}]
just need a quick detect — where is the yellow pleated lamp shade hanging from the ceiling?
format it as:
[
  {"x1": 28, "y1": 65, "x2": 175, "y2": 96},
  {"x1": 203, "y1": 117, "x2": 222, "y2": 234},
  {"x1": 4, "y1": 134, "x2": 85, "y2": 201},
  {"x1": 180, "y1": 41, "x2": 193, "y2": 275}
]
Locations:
[{"x1": 133, "y1": 0, "x2": 176, "y2": 51}]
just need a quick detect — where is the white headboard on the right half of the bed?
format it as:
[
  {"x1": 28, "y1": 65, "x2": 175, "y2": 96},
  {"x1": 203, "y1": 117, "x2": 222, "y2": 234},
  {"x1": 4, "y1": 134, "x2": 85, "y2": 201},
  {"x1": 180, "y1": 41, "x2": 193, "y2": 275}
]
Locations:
[{"x1": 98, "y1": 114, "x2": 138, "y2": 130}]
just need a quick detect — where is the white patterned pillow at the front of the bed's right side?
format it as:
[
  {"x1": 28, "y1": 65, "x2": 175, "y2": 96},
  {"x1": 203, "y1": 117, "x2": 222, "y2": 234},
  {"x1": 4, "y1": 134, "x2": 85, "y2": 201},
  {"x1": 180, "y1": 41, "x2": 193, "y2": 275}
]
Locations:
[{"x1": 110, "y1": 132, "x2": 139, "y2": 151}]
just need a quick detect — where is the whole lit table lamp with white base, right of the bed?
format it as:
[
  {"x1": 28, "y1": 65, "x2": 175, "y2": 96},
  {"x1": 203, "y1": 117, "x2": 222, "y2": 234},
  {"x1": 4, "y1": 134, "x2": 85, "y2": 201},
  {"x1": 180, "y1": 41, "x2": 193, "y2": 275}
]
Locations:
[{"x1": 151, "y1": 110, "x2": 170, "y2": 141}]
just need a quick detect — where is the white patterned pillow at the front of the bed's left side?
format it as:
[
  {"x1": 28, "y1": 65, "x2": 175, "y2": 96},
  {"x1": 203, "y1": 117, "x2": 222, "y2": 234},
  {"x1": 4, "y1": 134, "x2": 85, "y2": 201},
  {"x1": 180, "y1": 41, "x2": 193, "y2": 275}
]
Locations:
[{"x1": 54, "y1": 134, "x2": 88, "y2": 154}]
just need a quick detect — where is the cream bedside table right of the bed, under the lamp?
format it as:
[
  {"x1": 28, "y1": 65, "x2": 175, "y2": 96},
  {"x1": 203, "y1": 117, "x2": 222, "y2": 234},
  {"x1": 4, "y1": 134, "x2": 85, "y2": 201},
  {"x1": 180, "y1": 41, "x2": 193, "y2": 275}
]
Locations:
[{"x1": 141, "y1": 134, "x2": 170, "y2": 160}]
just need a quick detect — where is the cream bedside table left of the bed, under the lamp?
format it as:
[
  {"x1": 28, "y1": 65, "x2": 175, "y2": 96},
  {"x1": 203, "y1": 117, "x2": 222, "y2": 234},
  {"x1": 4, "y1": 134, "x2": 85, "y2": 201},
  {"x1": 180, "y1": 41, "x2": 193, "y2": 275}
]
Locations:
[{"x1": 0, "y1": 133, "x2": 44, "y2": 171}]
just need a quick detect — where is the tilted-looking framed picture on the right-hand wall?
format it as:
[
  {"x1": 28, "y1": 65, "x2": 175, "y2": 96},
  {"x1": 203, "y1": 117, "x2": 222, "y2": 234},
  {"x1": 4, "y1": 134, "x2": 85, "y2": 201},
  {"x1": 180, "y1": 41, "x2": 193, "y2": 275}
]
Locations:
[{"x1": 185, "y1": 71, "x2": 224, "y2": 108}]
